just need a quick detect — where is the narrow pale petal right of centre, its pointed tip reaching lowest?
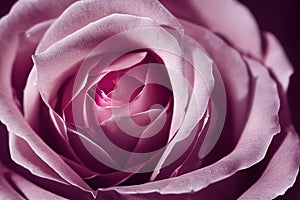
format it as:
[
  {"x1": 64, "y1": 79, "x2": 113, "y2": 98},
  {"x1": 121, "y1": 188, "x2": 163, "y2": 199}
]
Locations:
[{"x1": 151, "y1": 22, "x2": 219, "y2": 180}]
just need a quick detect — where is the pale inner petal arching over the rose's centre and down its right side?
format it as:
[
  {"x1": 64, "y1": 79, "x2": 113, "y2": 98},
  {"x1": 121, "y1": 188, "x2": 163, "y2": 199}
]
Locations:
[{"x1": 34, "y1": 14, "x2": 192, "y2": 161}]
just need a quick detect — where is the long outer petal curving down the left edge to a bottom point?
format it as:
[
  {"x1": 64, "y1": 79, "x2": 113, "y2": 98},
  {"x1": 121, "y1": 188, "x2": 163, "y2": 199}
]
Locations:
[{"x1": 0, "y1": 0, "x2": 95, "y2": 196}]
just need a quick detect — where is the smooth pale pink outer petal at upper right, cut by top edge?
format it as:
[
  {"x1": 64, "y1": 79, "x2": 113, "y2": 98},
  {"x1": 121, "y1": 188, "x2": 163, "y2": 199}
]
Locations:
[{"x1": 161, "y1": 0, "x2": 262, "y2": 58}]
